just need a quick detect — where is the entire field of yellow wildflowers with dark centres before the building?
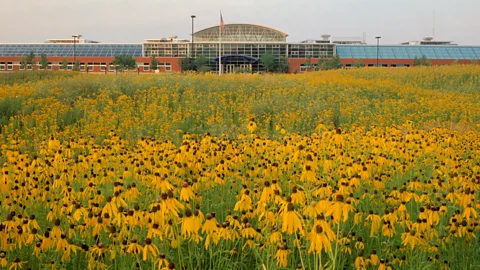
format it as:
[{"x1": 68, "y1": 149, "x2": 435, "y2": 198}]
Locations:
[{"x1": 0, "y1": 65, "x2": 480, "y2": 270}]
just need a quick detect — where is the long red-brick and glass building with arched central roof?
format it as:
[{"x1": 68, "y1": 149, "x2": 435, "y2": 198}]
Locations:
[{"x1": 0, "y1": 23, "x2": 480, "y2": 73}]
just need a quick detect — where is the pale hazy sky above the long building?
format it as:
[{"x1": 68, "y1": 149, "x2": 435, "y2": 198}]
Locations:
[{"x1": 0, "y1": 0, "x2": 480, "y2": 45}]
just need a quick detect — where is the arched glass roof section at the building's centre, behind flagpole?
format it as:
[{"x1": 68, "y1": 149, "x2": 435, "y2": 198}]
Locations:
[{"x1": 194, "y1": 23, "x2": 288, "y2": 42}]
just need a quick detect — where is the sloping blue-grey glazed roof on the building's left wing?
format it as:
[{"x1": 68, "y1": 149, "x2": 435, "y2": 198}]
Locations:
[{"x1": 0, "y1": 43, "x2": 142, "y2": 57}]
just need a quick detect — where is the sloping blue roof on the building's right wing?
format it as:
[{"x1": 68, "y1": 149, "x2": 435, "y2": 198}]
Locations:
[{"x1": 336, "y1": 45, "x2": 480, "y2": 59}]
